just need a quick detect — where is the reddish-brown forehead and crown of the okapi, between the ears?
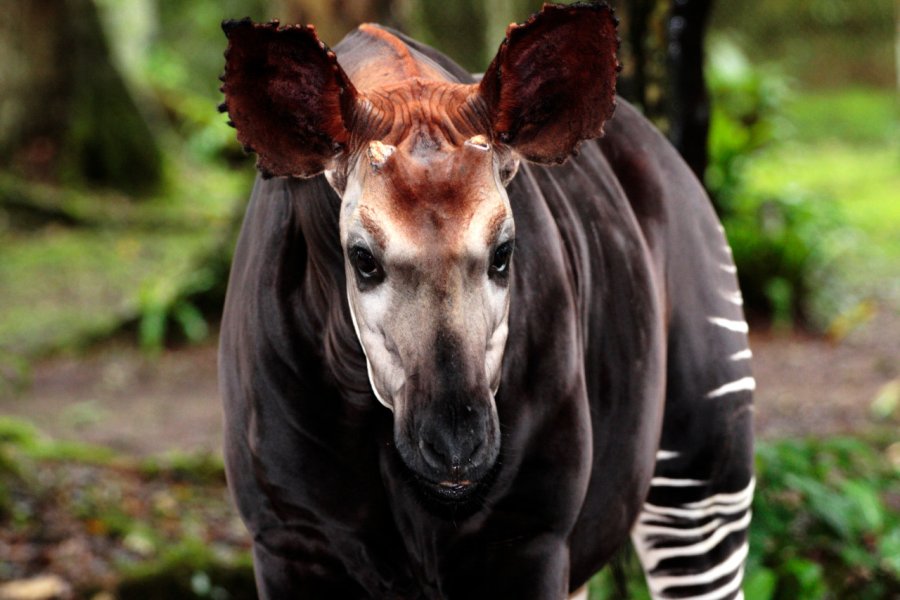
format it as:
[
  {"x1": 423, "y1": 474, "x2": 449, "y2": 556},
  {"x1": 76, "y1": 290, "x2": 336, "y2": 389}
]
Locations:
[{"x1": 348, "y1": 54, "x2": 503, "y2": 245}]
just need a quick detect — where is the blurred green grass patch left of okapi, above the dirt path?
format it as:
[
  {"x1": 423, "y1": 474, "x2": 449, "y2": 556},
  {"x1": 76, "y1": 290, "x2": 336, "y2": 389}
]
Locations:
[{"x1": 0, "y1": 227, "x2": 206, "y2": 356}]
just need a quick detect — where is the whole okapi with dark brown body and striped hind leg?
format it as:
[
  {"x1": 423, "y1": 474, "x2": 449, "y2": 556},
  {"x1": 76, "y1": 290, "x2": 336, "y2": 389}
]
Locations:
[{"x1": 220, "y1": 4, "x2": 755, "y2": 599}]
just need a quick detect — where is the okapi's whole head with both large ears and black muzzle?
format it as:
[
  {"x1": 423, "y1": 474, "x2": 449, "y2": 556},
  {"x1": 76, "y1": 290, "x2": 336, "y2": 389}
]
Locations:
[{"x1": 222, "y1": 4, "x2": 618, "y2": 501}]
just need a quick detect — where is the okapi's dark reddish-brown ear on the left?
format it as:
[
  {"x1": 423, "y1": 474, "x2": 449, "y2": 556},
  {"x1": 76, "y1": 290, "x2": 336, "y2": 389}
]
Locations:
[{"x1": 219, "y1": 19, "x2": 358, "y2": 177}]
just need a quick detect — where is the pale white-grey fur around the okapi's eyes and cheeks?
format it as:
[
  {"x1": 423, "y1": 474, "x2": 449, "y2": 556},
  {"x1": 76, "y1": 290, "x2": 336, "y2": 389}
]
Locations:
[{"x1": 340, "y1": 143, "x2": 515, "y2": 413}]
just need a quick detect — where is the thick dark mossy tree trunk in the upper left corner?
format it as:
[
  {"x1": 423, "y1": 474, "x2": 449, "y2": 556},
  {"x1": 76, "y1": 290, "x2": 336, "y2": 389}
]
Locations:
[{"x1": 0, "y1": 0, "x2": 162, "y2": 194}]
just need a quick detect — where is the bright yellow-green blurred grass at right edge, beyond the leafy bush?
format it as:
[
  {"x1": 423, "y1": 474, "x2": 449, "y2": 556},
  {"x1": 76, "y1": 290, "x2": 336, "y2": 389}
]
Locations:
[{"x1": 745, "y1": 88, "x2": 900, "y2": 320}]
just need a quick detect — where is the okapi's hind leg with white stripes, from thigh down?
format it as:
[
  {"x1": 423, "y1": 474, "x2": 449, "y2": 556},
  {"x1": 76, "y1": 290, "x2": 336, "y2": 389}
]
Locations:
[{"x1": 631, "y1": 228, "x2": 756, "y2": 600}]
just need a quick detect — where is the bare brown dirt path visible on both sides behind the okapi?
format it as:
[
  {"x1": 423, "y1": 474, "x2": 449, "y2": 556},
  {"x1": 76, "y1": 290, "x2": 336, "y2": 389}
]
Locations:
[{"x1": 0, "y1": 309, "x2": 900, "y2": 455}]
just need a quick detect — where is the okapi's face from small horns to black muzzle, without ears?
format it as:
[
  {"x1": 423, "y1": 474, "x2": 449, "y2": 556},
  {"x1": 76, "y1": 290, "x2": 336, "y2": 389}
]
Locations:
[{"x1": 341, "y1": 131, "x2": 515, "y2": 494}]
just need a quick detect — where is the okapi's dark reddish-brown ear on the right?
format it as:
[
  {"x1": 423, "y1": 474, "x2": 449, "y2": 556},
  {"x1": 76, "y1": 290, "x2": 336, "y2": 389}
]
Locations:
[{"x1": 479, "y1": 4, "x2": 619, "y2": 164}]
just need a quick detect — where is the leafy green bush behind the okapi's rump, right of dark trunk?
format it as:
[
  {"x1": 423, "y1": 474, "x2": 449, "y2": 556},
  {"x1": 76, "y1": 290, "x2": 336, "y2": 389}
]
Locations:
[{"x1": 706, "y1": 38, "x2": 845, "y2": 327}]
